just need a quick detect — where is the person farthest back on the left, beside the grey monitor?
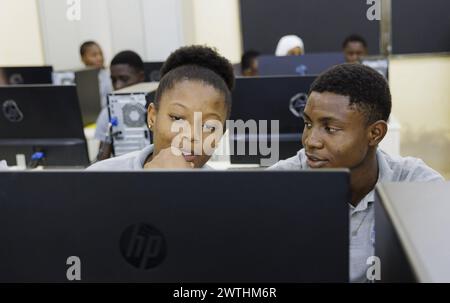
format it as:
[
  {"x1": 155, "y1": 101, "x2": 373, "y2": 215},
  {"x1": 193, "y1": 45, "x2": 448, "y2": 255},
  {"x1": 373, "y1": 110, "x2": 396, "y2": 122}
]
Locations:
[{"x1": 80, "y1": 41, "x2": 113, "y2": 107}]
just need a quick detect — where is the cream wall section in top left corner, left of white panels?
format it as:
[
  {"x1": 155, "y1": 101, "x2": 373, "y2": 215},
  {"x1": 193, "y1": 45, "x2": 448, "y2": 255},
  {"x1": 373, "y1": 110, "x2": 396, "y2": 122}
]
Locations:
[{"x1": 0, "y1": 0, "x2": 44, "y2": 66}]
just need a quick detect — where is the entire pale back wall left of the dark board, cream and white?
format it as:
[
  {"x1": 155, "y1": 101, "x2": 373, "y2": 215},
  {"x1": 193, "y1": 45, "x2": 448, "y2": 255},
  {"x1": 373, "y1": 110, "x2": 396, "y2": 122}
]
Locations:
[{"x1": 0, "y1": 0, "x2": 242, "y2": 69}]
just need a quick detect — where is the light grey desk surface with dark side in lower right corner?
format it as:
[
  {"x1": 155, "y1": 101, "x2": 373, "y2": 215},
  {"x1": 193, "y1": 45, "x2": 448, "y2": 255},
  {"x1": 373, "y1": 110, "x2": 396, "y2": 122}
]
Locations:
[{"x1": 375, "y1": 182, "x2": 450, "y2": 283}]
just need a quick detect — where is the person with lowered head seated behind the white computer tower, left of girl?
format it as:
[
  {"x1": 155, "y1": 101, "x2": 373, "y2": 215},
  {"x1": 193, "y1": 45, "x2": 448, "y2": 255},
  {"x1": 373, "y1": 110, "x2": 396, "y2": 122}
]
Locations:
[{"x1": 95, "y1": 50, "x2": 145, "y2": 161}]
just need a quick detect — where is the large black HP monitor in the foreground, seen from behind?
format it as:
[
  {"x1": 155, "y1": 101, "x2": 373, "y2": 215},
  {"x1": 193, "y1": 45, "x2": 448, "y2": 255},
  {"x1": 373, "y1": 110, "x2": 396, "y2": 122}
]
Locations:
[{"x1": 0, "y1": 170, "x2": 350, "y2": 283}]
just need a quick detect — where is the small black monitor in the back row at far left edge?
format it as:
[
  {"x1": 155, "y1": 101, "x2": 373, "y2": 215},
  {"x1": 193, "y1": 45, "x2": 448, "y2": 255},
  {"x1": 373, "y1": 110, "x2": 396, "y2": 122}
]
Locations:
[{"x1": 0, "y1": 66, "x2": 53, "y2": 85}]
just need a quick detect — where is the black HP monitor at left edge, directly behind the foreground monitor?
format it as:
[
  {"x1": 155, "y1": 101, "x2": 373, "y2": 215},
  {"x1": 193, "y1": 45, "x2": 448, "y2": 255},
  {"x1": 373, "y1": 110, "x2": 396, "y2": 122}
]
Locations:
[{"x1": 0, "y1": 85, "x2": 89, "y2": 167}]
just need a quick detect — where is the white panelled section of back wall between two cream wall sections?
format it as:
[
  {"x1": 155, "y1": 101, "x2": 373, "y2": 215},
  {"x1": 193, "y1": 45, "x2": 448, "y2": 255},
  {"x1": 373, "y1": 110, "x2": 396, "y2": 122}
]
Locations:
[{"x1": 38, "y1": 0, "x2": 184, "y2": 69}]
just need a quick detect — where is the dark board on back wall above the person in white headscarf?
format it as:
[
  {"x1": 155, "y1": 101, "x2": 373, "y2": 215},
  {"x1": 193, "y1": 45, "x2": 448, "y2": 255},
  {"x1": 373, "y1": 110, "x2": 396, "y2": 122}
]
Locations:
[{"x1": 240, "y1": 0, "x2": 380, "y2": 55}]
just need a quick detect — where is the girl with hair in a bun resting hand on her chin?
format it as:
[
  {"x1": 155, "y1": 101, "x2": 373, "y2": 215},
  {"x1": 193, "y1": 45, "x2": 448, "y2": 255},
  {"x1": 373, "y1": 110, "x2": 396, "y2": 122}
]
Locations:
[{"x1": 89, "y1": 46, "x2": 234, "y2": 171}]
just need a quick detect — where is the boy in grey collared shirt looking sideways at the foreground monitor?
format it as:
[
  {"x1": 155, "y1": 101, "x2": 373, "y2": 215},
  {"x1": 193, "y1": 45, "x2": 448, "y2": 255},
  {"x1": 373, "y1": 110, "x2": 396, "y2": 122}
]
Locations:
[{"x1": 270, "y1": 64, "x2": 443, "y2": 282}]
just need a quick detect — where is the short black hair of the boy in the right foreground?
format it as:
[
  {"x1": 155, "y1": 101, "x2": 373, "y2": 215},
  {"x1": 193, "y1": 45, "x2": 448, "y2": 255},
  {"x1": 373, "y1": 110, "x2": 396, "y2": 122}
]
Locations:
[{"x1": 309, "y1": 63, "x2": 392, "y2": 124}]
